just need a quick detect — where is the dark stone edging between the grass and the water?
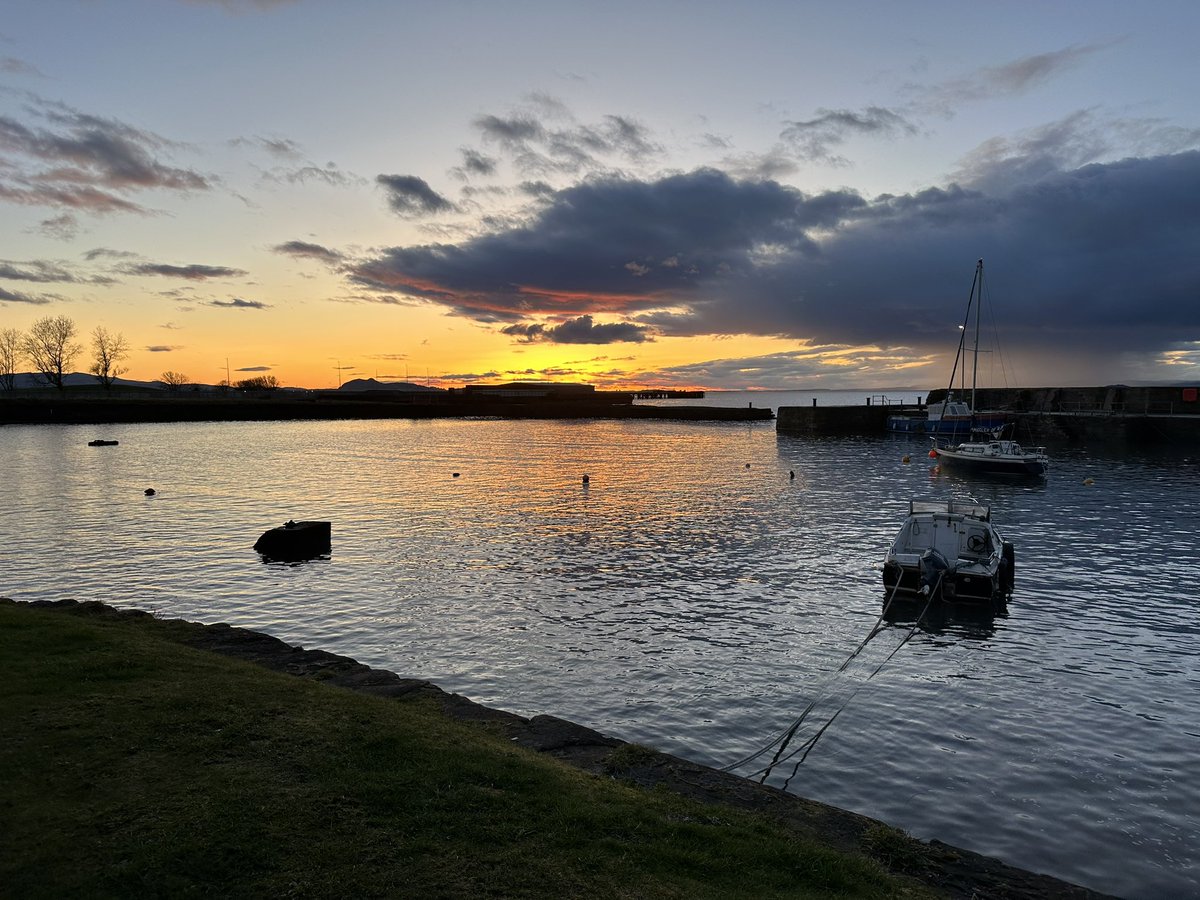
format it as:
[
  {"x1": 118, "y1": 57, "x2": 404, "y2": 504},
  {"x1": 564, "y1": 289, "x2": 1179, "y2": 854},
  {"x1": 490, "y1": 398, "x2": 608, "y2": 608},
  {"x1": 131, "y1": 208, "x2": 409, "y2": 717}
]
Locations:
[{"x1": 9, "y1": 598, "x2": 1106, "y2": 899}]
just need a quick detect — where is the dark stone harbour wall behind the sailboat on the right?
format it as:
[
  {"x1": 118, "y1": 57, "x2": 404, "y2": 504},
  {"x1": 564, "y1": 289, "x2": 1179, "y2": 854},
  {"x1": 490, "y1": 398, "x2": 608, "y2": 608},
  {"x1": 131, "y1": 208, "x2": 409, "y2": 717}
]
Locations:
[{"x1": 775, "y1": 385, "x2": 1200, "y2": 445}]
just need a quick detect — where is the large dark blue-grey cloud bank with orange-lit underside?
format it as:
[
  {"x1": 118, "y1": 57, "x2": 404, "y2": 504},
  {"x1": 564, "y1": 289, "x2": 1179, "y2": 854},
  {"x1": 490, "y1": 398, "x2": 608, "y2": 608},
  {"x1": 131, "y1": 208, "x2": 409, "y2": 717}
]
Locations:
[{"x1": 349, "y1": 151, "x2": 1200, "y2": 372}]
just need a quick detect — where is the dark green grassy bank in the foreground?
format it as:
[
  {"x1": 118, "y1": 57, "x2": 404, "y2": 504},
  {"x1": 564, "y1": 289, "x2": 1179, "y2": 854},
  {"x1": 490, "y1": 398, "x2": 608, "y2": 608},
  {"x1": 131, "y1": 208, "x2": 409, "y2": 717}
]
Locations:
[{"x1": 0, "y1": 604, "x2": 922, "y2": 899}]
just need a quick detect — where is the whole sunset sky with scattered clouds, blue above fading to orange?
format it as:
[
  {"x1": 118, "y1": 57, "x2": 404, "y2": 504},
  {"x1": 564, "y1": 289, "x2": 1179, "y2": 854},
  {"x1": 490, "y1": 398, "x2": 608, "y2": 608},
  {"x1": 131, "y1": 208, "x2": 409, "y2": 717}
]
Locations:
[{"x1": 0, "y1": 0, "x2": 1200, "y2": 390}]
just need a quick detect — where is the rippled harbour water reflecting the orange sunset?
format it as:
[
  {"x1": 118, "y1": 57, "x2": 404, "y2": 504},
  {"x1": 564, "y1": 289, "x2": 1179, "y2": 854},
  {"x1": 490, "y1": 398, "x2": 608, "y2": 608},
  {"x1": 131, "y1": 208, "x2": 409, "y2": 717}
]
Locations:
[{"x1": 0, "y1": 415, "x2": 1200, "y2": 898}]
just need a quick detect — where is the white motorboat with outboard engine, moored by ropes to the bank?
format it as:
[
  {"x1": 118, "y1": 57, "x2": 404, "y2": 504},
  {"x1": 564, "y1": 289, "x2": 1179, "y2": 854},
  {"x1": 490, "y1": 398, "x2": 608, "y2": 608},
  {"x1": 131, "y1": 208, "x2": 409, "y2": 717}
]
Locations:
[{"x1": 883, "y1": 500, "x2": 1016, "y2": 611}]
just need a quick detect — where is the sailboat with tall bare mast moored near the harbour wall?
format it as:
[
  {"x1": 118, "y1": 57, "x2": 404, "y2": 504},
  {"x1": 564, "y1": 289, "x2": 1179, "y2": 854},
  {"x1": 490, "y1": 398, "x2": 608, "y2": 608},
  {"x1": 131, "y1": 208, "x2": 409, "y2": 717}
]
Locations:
[{"x1": 929, "y1": 259, "x2": 1050, "y2": 475}]
